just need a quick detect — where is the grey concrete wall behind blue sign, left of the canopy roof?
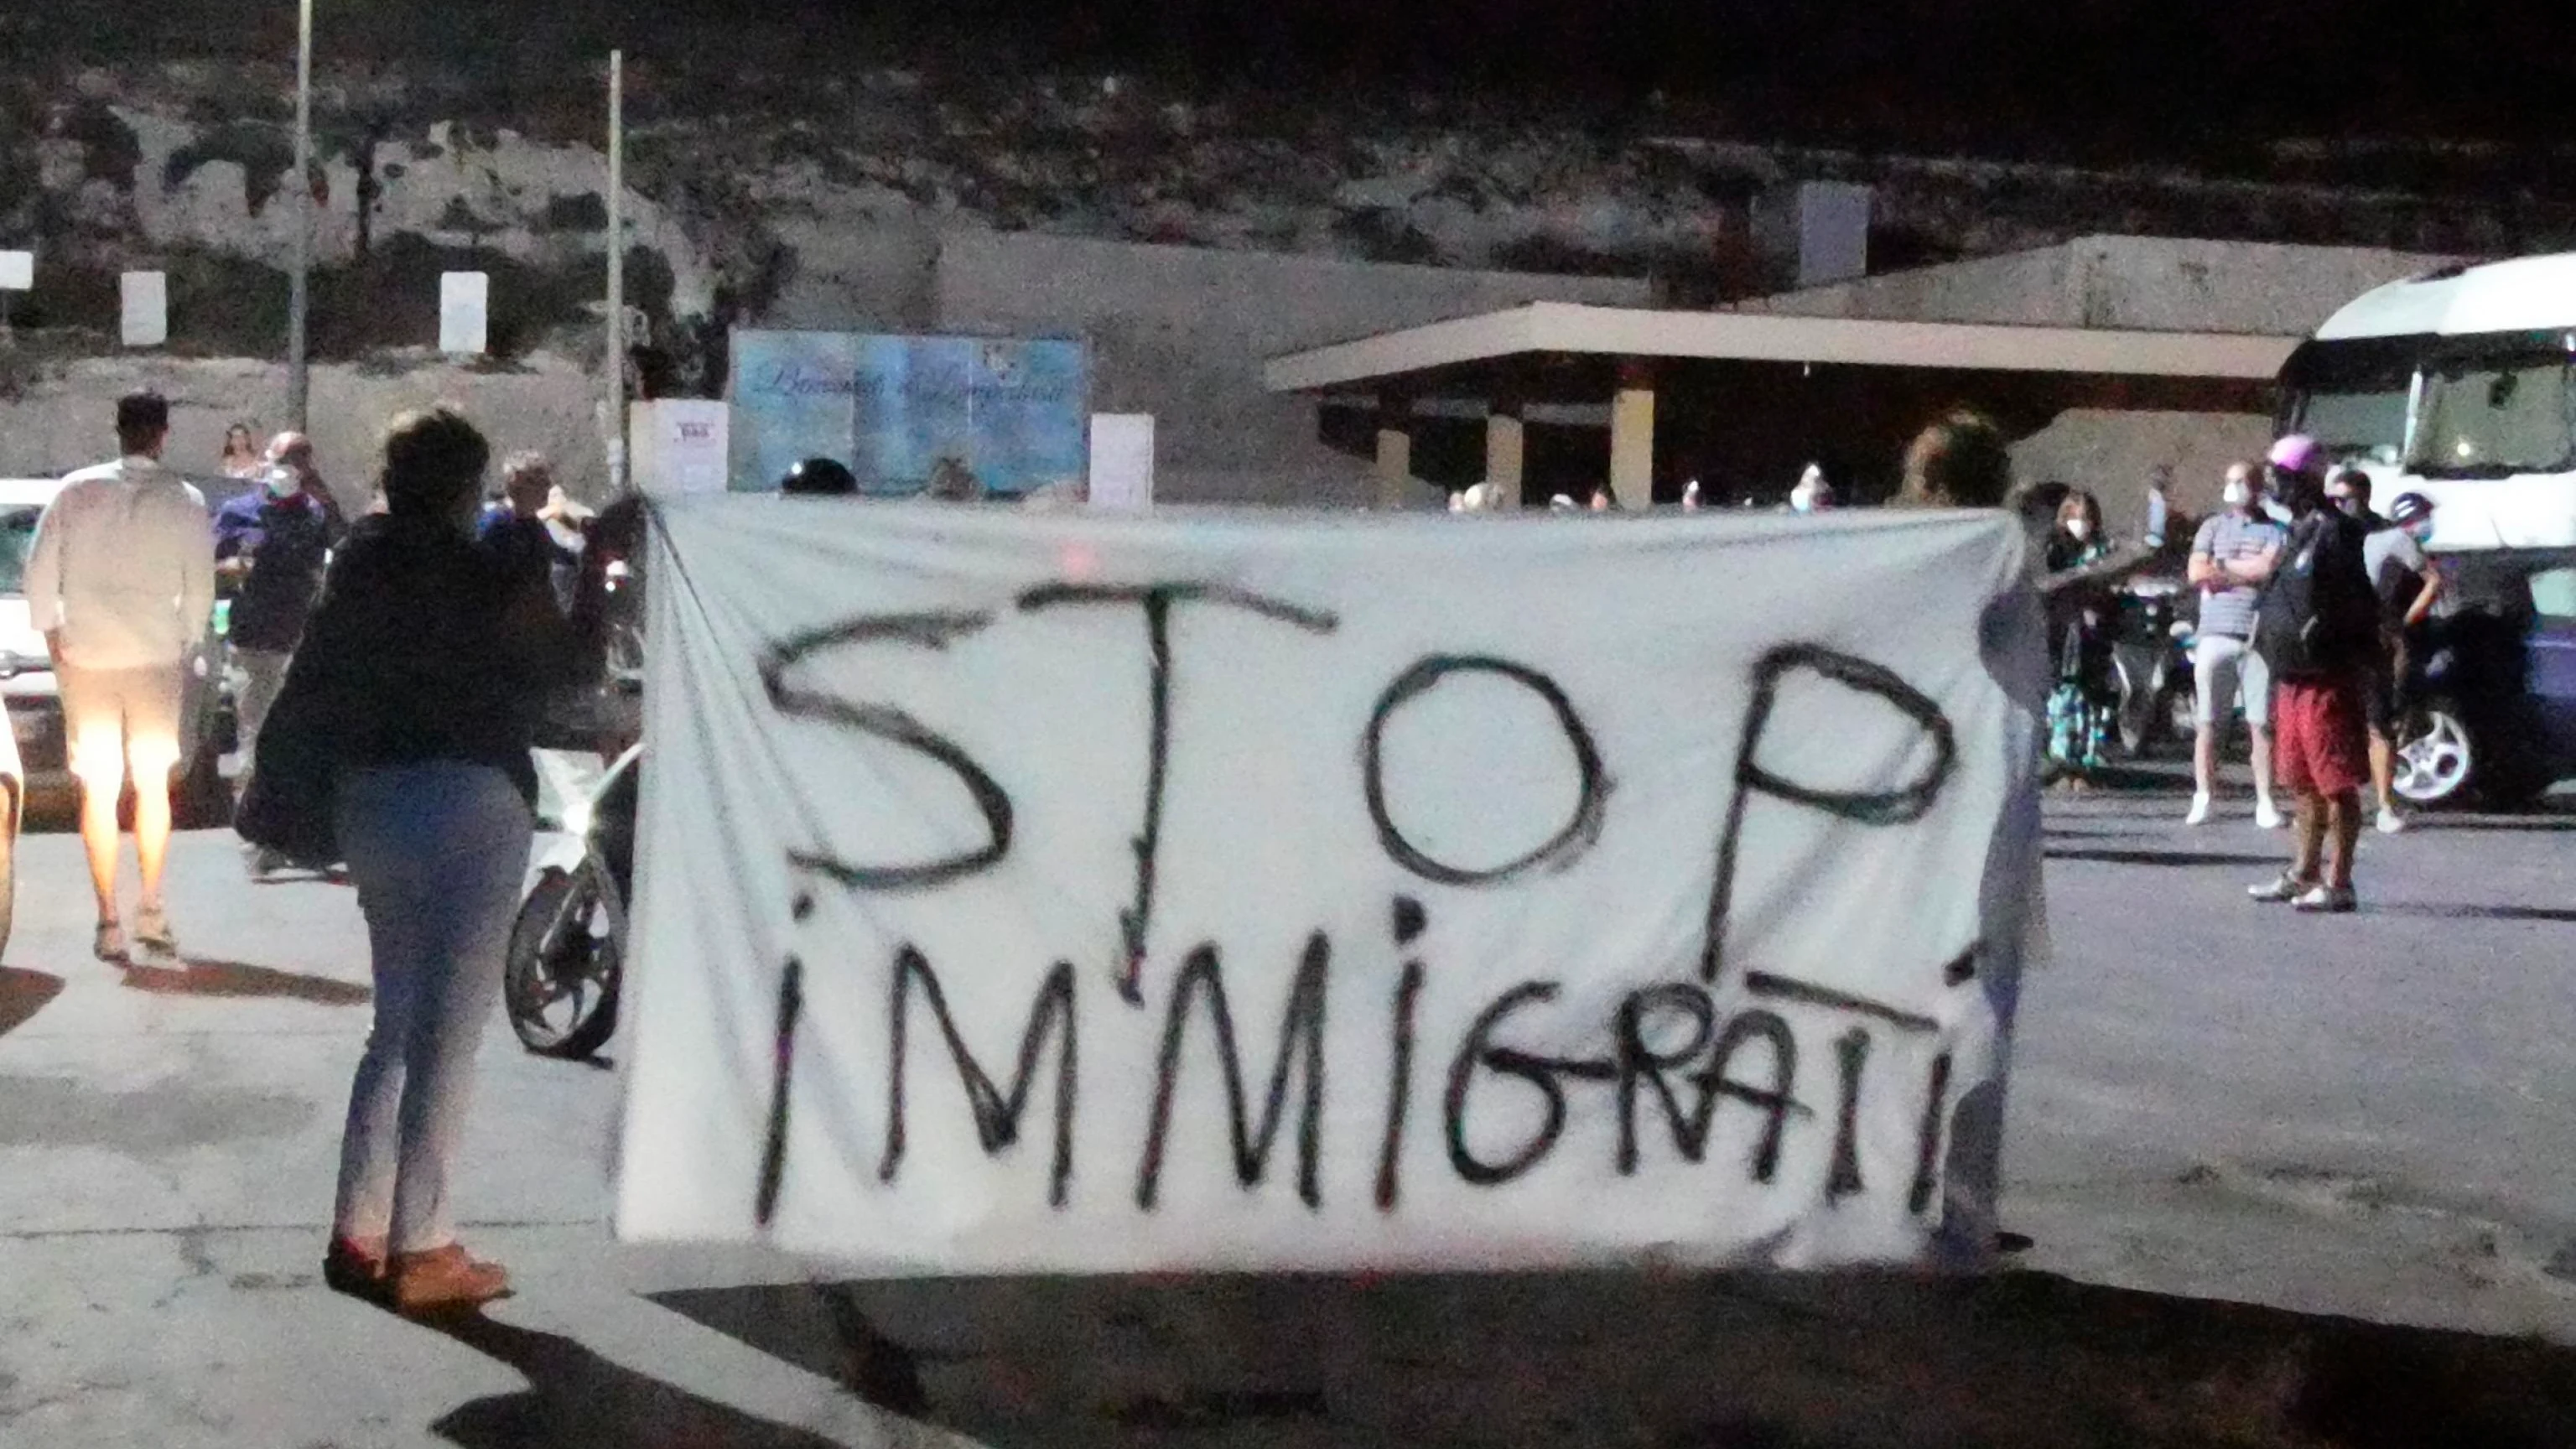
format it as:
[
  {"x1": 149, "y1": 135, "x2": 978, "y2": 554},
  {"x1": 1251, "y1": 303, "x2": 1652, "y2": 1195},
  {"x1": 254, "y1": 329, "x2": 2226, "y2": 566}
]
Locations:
[{"x1": 937, "y1": 232, "x2": 1649, "y2": 508}]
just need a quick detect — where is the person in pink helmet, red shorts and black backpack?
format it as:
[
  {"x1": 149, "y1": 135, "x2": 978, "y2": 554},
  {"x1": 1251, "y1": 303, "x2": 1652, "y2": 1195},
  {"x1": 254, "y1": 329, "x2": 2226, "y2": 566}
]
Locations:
[{"x1": 2249, "y1": 451, "x2": 2381, "y2": 916}]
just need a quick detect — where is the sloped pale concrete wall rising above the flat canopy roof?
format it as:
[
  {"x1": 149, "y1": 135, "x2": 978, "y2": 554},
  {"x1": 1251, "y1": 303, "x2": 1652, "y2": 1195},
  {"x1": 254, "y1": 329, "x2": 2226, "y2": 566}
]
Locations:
[{"x1": 1742, "y1": 237, "x2": 2458, "y2": 335}]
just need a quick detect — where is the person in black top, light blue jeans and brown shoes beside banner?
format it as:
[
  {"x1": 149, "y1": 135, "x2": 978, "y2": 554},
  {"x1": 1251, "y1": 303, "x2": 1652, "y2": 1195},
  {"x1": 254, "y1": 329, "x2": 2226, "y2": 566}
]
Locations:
[{"x1": 288, "y1": 408, "x2": 598, "y2": 1312}]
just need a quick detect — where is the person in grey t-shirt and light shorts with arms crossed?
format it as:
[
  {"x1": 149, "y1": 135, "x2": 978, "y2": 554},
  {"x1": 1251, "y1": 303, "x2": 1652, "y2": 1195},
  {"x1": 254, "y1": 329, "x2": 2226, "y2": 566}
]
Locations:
[{"x1": 2184, "y1": 464, "x2": 2288, "y2": 830}]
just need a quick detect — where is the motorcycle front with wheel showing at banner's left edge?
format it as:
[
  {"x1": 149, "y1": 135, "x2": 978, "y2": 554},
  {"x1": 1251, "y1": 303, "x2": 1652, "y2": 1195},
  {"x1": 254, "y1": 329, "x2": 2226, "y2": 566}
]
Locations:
[{"x1": 502, "y1": 745, "x2": 644, "y2": 1060}]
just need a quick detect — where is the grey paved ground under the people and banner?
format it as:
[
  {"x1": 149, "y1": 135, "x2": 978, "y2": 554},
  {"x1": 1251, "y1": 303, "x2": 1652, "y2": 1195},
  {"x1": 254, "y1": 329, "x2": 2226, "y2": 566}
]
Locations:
[{"x1": 0, "y1": 794, "x2": 2576, "y2": 1446}]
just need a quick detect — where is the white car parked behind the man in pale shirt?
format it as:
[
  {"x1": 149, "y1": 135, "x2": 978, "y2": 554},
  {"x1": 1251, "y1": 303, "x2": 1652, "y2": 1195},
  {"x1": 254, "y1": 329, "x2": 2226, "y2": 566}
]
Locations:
[{"x1": 0, "y1": 477, "x2": 235, "y2": 828}]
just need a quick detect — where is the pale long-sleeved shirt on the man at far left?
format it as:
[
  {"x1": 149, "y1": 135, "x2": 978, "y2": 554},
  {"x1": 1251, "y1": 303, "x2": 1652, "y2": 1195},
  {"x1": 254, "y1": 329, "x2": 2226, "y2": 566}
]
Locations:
[{"x1": 26, "y1": 456, "x2": 214, "y2": 670}]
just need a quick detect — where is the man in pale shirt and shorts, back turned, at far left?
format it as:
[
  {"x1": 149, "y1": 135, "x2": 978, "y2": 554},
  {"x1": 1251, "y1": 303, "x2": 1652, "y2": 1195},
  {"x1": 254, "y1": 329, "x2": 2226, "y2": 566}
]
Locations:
[{"x1": 26, "y1": 392, "x2": 214, "y2": 964}]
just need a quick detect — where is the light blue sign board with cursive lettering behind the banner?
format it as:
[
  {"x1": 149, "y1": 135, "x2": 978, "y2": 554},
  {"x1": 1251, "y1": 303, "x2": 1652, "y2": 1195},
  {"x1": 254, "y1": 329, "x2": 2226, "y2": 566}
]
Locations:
[{"x1": 731, "y1": 330, "x2": 1089, "y2": 497}]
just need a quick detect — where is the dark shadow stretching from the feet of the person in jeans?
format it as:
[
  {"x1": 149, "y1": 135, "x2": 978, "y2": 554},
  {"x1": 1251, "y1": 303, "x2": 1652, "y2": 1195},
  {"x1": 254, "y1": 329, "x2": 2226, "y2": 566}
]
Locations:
[{"x1": 418, "y1": 1312, "x2": 865, "y2": 1449}]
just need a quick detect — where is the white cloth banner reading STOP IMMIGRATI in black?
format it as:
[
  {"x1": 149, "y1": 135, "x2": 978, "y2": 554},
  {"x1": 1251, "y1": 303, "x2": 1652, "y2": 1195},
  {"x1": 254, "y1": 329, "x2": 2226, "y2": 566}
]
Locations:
[{"x1": 618, "y1": 497, "x2": 2040, "y2": 1274}]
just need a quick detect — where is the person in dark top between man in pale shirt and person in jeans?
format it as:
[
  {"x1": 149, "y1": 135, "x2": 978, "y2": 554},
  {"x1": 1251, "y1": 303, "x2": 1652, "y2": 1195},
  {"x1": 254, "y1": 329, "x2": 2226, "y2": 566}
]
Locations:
[{"x1": 214, "y1": 443, "x2": 340, "y2": 879}]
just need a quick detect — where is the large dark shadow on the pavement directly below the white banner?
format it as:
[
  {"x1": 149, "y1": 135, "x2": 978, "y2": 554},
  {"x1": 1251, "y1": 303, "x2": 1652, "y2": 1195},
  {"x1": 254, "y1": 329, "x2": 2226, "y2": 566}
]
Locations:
[{"x1": 649, "y1": 1271, "x2": 2576, "y2": 1449}]
